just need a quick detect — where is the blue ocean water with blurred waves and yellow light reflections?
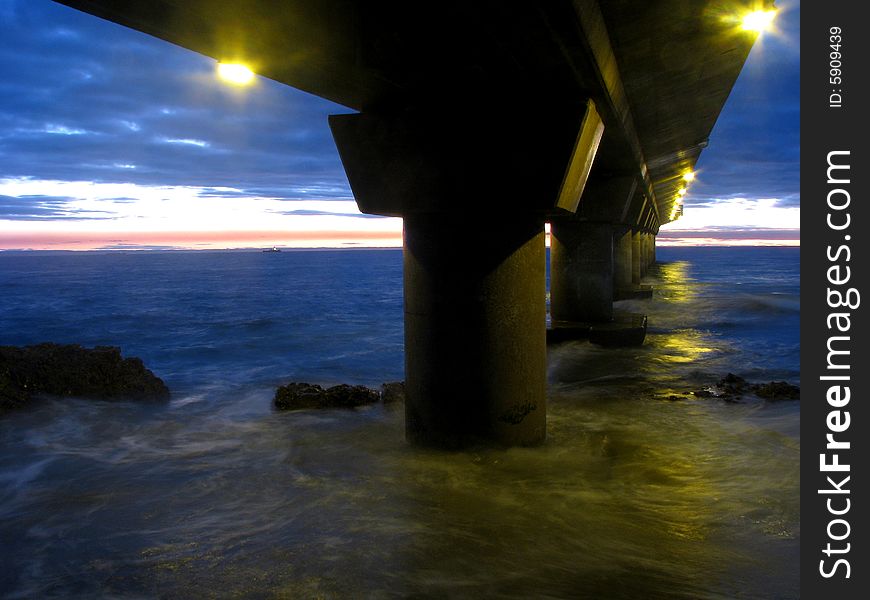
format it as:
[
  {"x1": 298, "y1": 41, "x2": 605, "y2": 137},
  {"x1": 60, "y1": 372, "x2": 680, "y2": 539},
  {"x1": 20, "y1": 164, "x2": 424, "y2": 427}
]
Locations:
[{"x1": 0, "y1": 248, "x2": 800, "y2": 599}]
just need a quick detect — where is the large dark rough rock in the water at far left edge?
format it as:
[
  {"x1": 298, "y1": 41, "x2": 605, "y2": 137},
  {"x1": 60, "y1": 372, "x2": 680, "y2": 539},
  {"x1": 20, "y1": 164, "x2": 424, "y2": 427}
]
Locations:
[{"x1": 0, "y1": 343, "x2": 169, "y2": 408}]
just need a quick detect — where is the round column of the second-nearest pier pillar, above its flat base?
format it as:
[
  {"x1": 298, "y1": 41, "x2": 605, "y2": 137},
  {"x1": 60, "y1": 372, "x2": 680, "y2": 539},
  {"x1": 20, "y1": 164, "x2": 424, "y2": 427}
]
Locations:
[{"x1": 550, "y1": 220, "x2": 613, "y2": 322}]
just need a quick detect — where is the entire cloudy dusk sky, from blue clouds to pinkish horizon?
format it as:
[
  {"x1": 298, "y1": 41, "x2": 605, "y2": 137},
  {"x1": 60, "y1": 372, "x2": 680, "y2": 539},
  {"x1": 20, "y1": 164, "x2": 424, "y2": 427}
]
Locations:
[{"x1": 0, "y1": 0, "x2": 800, "y2": 250}]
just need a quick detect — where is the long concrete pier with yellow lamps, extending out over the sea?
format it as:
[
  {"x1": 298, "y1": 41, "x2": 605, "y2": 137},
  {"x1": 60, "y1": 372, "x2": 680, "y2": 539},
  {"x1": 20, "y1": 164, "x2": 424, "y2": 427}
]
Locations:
[{"x1": 56, "y1": 0, "x2": 773, "y2": 447}]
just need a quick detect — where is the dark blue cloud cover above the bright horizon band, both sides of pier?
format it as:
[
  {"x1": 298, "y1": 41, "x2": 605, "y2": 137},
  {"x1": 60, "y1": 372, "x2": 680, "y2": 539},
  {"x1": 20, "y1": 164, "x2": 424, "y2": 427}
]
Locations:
[{"x1": 0, "y1": 0, "x2": 800, "y2": 223}]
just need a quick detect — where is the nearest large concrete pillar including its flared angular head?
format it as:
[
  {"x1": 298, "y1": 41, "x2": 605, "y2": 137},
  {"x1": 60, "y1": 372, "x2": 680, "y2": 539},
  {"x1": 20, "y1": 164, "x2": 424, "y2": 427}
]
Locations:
[{"x1": 329, "y1": 103, "x2": 604, "y2": 448}]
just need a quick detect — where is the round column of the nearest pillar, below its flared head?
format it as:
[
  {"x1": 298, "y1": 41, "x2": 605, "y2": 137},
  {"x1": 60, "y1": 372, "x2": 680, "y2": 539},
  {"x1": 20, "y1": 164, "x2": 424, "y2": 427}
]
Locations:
[{"x1": 404, "y1": 213, "x2": 547, "y2": 447}]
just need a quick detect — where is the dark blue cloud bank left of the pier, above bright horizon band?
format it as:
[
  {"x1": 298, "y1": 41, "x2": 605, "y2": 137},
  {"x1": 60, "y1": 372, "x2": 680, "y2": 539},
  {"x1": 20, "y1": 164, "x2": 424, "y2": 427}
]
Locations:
[{"x1": 0, "y1": 0, "x2": 351, "y2": 198}]
